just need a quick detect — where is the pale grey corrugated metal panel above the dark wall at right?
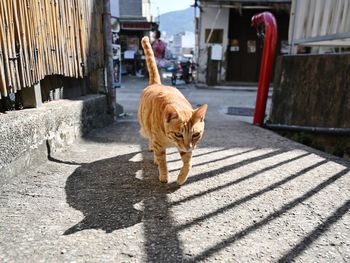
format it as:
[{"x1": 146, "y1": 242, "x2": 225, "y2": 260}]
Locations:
[{"x1": 289, "y1": 0, "x2": 350, "y2": 45}]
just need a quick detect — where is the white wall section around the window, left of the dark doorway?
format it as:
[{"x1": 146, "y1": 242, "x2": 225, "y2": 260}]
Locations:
[{"x1": 197, "y1": 5, "x2": 230, "y2": 83}]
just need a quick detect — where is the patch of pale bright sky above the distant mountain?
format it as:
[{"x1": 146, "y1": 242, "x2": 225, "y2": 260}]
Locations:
[{"x1": 151, "y1": 0, "x2": 194, "y2": 17}]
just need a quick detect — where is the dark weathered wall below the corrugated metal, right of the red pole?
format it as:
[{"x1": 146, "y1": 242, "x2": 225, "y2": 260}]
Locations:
[{"x1": 270, "y1": 54, "x2": 350, "y2": 128}]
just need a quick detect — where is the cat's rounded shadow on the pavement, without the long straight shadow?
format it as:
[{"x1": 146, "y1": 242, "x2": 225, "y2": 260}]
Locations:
[{"x1": 64, "y1": 152, "x2": 178, "y2": 235}]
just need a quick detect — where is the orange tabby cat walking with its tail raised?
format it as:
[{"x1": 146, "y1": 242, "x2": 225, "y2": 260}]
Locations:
[{"x1": 138, "y1": 37, "x2": 208, "y2": 185}]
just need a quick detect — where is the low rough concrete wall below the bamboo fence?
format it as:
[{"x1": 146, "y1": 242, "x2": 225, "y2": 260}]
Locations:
[{"x1": 0, "y1": 95, "x2": 113, "y2": 185}]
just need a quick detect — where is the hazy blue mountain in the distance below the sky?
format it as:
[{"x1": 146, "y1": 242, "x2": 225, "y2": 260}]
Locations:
[{"x1": 155, "y1": 7, "x2": 194, "y2": 36}]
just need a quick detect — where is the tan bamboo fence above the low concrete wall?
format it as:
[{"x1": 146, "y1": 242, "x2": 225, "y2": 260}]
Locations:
[{"x1": 0, "y1": 0, "x2": 103, "y2": 99}]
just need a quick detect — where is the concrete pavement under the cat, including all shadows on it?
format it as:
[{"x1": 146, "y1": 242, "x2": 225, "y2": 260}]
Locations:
[{"x1": 0, "y1": 78, "x2": 350, "y2": 262}]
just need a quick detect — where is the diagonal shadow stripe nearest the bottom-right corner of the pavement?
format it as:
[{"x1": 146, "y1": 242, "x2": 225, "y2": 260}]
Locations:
[{"x1": 278, "y1": 200, "x2": 350, "y2": 263}]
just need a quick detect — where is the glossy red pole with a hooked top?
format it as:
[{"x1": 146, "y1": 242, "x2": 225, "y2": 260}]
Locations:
[{"x1": 252, "y1": 12, "x2": 277, "y2": 126}]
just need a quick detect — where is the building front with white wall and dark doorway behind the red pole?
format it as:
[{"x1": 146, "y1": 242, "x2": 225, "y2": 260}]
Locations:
[{"x1": 197, "y1": 0, "x2": 291, "y2": 85}]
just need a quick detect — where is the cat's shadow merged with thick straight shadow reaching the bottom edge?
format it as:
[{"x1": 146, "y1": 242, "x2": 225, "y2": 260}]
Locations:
[{"x1": 64, "y1": 152, "x2": 182, "y2": 262}]
